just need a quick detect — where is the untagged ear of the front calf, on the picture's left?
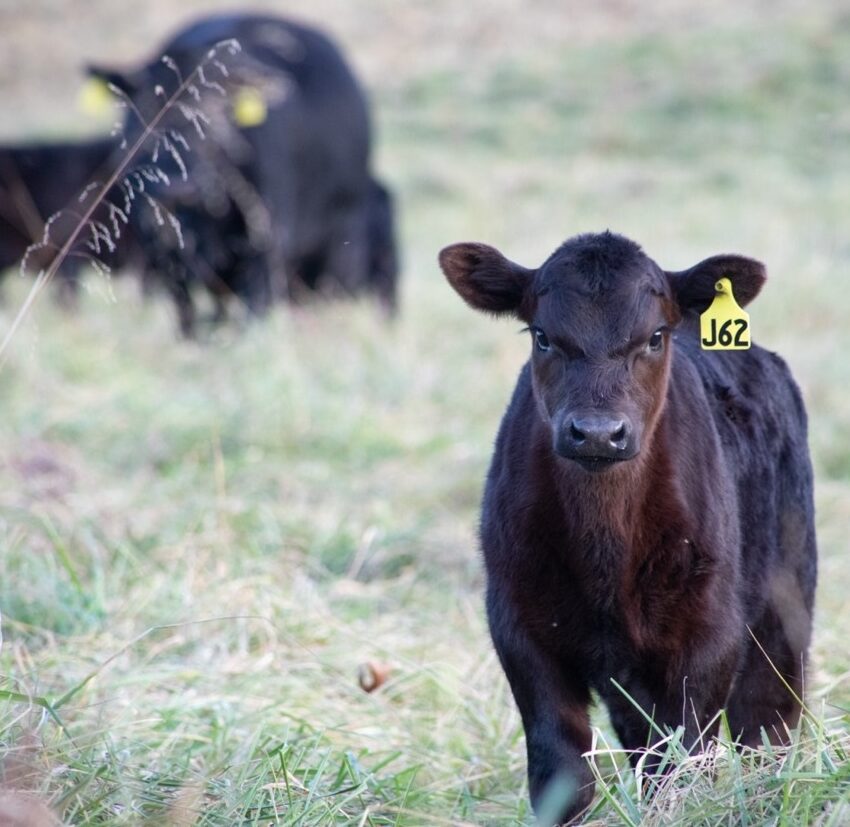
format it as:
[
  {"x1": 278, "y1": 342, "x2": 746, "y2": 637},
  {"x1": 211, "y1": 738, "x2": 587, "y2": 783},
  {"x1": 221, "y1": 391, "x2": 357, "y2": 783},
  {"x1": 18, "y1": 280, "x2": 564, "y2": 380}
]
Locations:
[{"x1": 440, "y1": 242, "x2": 534, "y2": 316}]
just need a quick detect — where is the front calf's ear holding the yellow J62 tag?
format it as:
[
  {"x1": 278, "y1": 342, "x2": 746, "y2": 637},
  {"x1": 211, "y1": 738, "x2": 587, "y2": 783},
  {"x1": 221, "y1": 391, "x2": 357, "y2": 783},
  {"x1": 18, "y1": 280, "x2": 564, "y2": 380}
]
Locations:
[{"x1": 667, "y1": 255, "x2": 767, "y2": 313}]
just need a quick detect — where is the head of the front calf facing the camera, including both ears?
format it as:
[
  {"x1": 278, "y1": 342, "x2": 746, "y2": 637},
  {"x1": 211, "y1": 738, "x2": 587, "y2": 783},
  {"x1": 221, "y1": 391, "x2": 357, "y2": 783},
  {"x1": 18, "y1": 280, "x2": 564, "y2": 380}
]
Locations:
[{"x1": 440, "y1": 232, "x2": 765, "y2": 471}]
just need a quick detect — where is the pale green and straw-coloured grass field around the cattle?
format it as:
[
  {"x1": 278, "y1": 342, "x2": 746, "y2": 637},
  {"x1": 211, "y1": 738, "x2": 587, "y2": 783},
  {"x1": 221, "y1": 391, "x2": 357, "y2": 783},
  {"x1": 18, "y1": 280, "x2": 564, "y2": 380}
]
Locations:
[{"x1": 0, "y1": 0, "x2": 850, "y2": 827}]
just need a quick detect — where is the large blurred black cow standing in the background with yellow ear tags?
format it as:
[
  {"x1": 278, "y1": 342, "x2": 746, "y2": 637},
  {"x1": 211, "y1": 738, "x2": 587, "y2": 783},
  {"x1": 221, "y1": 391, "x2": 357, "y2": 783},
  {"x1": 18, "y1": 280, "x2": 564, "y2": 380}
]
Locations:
[{"x1": 90, "y1": 14, "x2": 397, "y2": 335}]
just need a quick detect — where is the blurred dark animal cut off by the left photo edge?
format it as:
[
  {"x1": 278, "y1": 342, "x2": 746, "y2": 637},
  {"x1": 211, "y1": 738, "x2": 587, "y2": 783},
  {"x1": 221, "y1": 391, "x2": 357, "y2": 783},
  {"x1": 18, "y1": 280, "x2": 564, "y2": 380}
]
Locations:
[{"x1": 0, "y1": 137, "x2": 135, "y2": 303}]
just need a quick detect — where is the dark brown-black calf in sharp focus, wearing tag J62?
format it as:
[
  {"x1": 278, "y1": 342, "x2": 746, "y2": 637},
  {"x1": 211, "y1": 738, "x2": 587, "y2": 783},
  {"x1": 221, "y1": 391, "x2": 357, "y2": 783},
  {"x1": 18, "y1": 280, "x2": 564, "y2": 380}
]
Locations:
[{"x1": 440, "y1": 233, "x2": 816, "y2": 820}]
